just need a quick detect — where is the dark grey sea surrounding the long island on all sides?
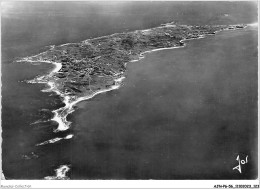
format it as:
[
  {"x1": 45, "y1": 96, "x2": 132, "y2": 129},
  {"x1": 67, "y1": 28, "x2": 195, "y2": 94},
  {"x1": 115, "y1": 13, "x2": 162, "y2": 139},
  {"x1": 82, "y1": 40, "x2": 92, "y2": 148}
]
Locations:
[{"x1": 1, "y1": 2, "x2": 257, "y2": 179}]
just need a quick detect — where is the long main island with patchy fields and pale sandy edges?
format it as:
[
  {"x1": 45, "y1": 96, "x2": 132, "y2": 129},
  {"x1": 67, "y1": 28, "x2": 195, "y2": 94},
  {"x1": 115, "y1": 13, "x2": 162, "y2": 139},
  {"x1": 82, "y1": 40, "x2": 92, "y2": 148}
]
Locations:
[{"x1": 19, "y1": 23, "x2": 246, "y2": 131}]
